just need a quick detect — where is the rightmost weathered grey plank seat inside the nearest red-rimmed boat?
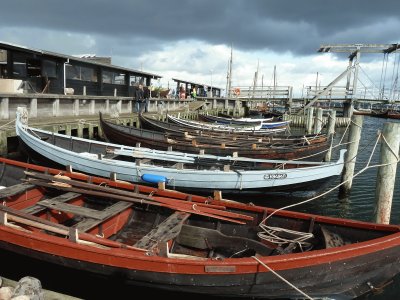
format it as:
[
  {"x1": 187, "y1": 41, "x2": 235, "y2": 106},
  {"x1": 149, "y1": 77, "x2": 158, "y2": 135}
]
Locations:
[{"x1": 134, "y1": 212, "x2": 190, "y2": 250}]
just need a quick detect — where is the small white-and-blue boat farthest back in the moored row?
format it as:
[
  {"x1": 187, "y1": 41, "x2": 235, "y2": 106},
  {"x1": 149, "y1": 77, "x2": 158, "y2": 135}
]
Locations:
[{"x1": 199, "y1": 114, "x2": 290, "y2": 129}]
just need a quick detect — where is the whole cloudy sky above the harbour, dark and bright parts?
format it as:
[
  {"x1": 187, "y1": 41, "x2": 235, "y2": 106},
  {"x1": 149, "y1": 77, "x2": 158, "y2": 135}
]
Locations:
[{"x1": 0, "y1": 0, "x2": 400, "y2": 96}]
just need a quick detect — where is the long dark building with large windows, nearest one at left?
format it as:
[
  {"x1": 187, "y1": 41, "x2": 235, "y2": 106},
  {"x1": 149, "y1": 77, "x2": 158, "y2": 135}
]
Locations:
[{"x1": 0, "y1": 42, "x2": 162, "y2": 96}]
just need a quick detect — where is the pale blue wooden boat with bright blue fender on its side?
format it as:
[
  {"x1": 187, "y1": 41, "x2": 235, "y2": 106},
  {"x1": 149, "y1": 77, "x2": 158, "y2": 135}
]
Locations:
[{"x1": 16, "y1": 111, "x2": 345, "y2": 193}]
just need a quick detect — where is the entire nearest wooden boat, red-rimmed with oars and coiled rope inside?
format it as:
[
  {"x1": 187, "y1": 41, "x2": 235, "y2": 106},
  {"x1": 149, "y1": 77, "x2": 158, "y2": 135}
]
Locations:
[{"x1": 0, "y1": 158, "x2": 400, "y2": 299}]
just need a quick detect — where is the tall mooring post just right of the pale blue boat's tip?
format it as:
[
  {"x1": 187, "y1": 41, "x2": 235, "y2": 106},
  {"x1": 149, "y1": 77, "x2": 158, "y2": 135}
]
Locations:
[{"x1": 340, "y1": 115, "x2": 363, "y2": 195}]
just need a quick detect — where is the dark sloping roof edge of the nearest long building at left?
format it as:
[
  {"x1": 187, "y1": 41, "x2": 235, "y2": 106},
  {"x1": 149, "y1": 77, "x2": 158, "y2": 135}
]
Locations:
[{"x1": 0, "y1": 41, "x2": 162, "y2": 78}]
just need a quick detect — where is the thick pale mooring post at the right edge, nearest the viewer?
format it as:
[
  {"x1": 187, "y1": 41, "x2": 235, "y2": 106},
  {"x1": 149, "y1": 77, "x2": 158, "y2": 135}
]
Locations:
[{"x1": 374, "y1": 123, "x2": 400, "y2": 224}]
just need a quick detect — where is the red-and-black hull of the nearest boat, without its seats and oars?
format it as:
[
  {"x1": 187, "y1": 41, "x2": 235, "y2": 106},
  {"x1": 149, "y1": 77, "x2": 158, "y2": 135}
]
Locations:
[{"x1": 0, "y1": 158, "x2": 400, "y2": 298}]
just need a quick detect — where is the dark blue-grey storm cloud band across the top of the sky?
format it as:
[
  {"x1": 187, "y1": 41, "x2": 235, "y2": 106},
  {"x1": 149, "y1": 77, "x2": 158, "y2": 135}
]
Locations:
[{"x1": 0, "y1": 0, "x2": 400, "y2": 55}]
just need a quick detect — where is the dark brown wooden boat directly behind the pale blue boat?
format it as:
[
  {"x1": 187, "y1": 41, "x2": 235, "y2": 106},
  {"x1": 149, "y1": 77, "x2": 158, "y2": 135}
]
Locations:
[{"x1": 100, "y1": 114, "x2": 330, "y2": 161}]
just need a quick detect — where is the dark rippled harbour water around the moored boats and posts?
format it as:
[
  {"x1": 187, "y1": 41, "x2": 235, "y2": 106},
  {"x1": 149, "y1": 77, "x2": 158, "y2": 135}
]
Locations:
[{"x1": 0, "y1": 117, "x2": 400, "y2": 300}]
